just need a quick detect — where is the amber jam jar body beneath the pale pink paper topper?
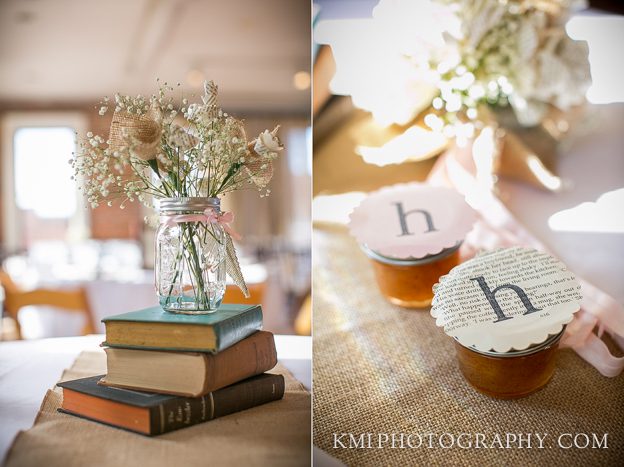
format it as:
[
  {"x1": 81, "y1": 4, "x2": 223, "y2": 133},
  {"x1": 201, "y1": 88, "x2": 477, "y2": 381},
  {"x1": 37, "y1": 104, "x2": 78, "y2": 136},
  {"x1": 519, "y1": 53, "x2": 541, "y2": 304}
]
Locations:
[{"x1": 362, "y1": 243, "x2": 461, "y2": 308}]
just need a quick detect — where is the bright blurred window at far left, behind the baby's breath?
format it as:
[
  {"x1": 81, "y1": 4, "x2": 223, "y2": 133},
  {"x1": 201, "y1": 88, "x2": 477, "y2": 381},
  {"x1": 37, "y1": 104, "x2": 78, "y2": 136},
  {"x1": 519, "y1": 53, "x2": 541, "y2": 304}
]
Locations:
[{"x1": 0, "y1": 112, "x2": 89, "y2": 252}]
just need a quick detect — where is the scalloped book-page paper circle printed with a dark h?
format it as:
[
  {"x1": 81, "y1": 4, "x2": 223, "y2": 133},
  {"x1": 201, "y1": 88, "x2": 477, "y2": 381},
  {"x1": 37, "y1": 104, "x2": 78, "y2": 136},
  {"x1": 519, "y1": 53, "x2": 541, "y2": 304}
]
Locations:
[{"x1": 431, "y1": 247, "x2": 581, "y2": 352}]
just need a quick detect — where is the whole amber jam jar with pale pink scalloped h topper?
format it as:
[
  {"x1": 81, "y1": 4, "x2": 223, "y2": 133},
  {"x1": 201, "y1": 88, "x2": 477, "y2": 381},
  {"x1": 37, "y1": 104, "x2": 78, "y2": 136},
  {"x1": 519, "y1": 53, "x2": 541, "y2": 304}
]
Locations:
[{"x1": 349, "y1": 183, "x2": 476, "y2": 308}]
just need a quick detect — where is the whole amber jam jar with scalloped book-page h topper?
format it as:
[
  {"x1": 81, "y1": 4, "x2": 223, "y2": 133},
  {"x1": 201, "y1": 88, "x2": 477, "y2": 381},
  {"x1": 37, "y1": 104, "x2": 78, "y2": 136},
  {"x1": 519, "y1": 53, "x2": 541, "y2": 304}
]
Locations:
[{"x1": 431, "y1": 246, "x2": 582, "y2": 399}]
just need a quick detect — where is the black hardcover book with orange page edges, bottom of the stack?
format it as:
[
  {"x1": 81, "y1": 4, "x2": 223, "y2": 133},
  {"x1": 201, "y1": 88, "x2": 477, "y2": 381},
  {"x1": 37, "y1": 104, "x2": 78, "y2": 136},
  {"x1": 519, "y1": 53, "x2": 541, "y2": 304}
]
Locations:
[{"x1": 58, "y1": 373, "x2": 285, "y2": 436}]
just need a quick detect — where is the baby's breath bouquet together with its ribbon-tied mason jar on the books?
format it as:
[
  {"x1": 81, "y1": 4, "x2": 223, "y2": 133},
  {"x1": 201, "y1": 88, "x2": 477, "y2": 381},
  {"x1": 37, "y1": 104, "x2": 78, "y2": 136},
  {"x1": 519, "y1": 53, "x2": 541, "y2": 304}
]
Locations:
[{"x1": 72, "y1": 81, "x2": 283, "y2": 312}]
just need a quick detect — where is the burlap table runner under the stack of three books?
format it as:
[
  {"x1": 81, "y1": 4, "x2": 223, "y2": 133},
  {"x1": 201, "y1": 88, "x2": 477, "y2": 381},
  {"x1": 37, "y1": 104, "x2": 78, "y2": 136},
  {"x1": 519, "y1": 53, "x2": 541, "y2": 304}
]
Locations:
[{"x1": 5, "y1": 352, "x2": 311, "y2": 467}]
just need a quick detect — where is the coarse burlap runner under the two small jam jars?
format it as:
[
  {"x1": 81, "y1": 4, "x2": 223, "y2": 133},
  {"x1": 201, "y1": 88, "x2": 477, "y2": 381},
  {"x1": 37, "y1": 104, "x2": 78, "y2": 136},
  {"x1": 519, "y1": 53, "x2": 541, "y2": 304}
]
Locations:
[{"x1": 313, "y1": 228, "x2": 624, "y2": 466}]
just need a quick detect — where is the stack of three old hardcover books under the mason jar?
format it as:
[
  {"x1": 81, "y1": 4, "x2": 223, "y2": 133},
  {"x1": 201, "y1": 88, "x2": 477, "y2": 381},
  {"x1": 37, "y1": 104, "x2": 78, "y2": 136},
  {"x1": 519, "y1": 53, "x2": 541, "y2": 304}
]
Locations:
[{"x1": 59, "y1": 304, "x2": 284, "y2": 436}]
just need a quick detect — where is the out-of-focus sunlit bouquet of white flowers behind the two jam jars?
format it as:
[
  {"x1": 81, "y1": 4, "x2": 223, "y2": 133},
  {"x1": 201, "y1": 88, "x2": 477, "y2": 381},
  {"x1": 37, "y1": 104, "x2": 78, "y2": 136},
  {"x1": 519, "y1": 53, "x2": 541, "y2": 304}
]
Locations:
[{"x1": 318, "y1": 0, "x2": 591, "y2": 189}]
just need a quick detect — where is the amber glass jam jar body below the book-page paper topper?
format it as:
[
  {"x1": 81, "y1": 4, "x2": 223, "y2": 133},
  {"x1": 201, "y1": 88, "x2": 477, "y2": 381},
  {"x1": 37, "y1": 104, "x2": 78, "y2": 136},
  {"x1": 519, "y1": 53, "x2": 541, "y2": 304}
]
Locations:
[{"x1": 455, "y1": 330, "x2": 563, "y2": 399}]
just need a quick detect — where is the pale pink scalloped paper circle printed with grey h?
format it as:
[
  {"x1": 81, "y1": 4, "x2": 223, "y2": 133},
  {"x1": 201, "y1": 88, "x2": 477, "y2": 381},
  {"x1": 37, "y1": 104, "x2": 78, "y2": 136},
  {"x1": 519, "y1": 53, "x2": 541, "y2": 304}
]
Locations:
[{"x1": 349, "y1": 183, "x2": 476, "y2": 259}]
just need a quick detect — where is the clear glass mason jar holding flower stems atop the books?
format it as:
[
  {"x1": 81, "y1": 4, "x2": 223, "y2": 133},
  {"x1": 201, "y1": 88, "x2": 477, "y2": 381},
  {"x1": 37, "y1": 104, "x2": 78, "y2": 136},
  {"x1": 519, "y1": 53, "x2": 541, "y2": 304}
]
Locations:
[{"x1": 155, "y1": 198, "x2": 226, "y2": 314}]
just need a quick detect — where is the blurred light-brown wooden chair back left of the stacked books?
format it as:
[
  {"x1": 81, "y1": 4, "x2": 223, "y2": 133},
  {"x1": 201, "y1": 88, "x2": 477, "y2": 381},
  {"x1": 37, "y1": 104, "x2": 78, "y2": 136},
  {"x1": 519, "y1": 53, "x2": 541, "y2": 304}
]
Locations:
[{"x1": 0, "y1": 269, "x2": 95, "y2": 339}]
